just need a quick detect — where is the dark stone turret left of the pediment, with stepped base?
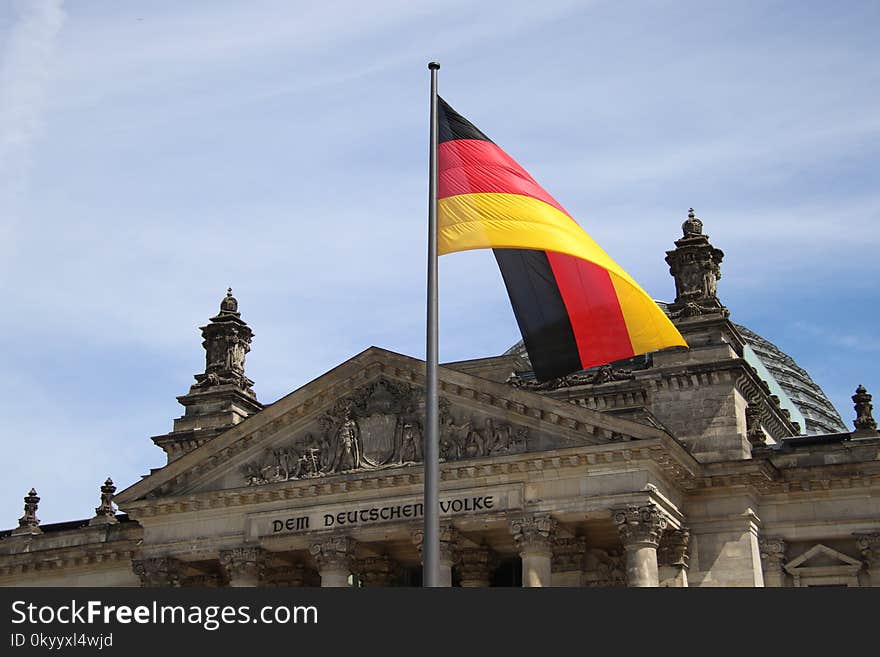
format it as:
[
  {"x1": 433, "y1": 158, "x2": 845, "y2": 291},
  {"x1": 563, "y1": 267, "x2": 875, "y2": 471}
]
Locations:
[{"x1": 153, "y1": 288, "x2": 263, "y2": 462}]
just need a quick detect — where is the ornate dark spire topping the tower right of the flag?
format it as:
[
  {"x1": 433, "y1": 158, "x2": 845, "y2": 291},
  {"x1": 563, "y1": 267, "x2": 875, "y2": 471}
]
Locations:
[{"x1": 666, "y1": 208, "x2": 729, "y2": 318}]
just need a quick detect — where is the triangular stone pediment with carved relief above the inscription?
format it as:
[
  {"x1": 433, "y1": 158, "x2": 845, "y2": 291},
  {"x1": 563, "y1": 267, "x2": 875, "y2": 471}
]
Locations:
[{"x1": 116, "y1": 347, "x2": 666, "y2": 505}]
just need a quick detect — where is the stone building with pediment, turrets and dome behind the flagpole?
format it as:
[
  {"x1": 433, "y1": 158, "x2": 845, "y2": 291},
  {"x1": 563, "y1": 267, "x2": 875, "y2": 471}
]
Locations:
[{"x1": 0, "y1": 212, "x2": 880, "y2": 587}]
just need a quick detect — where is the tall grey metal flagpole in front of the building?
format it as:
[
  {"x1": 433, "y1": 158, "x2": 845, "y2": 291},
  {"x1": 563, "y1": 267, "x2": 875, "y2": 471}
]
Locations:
[{"x1": 422, "y1": 62, "x2": 440, "y2": 587}]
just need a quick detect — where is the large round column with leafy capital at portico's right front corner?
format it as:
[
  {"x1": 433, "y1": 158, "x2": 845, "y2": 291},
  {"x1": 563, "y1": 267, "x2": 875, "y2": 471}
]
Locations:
[{"x1": 614, "y1": 504, "x2": 668, "y2": 587}]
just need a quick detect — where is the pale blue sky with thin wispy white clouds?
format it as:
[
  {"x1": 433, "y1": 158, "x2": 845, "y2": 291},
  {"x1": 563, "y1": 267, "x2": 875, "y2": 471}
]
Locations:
[{"x1": 0, "y1": 0, "x2": 880, "y2": 527}]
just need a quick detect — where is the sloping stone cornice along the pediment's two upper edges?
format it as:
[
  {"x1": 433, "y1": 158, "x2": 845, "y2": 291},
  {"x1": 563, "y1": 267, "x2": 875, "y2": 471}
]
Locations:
[{"x1": 115, "y1": 347, "x2": 667, "y2": 508}]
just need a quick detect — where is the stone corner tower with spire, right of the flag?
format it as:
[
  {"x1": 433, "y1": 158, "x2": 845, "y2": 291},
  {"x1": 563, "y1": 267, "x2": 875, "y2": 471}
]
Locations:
[{"x1": 650, "y1": 208, "x2": 800, "y2": 463}]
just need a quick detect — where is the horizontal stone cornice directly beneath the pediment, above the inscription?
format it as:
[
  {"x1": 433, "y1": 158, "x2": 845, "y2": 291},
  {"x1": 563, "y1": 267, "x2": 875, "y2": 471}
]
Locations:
[{"x1": 126, "y1": 435, "x2": 703, "y2": 519}]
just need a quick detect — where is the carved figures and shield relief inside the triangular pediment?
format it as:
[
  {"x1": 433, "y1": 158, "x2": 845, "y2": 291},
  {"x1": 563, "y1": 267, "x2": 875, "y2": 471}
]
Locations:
[{"x1": 242, "y1": 378, "x2": 528, "y2": 485}]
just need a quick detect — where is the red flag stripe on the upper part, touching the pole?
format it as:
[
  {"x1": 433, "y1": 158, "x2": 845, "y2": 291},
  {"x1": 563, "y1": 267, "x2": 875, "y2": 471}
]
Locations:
[{"x1": 437, "y1": 139, "x2": 574, "y2": 214}]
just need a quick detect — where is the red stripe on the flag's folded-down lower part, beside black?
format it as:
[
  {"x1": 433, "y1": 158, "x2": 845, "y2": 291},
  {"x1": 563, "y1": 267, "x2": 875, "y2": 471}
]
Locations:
[{"x1": 547, "y1": 251, "x2": 635, "y2": 369}]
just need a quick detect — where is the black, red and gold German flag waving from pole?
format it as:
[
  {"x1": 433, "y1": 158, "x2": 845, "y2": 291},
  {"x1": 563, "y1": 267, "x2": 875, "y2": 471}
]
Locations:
[{"x1": 437, "y1": 98, "x2": 687, "y2": 381}]
